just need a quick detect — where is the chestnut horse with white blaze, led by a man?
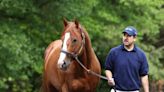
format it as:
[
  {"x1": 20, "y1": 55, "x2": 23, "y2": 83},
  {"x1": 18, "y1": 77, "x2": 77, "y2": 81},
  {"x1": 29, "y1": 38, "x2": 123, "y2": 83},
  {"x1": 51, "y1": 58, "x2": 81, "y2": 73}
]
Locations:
[{"x1": 42, "y1": 20, "x2": 101, "y2": 92}]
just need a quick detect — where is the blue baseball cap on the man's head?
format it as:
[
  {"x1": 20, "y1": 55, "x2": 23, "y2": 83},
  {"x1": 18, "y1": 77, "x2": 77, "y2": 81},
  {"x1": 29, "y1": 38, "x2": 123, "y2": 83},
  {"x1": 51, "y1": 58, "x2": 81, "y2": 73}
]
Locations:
[{"x1": 122, "y1": 26, "x2": 137, "y2": 36}]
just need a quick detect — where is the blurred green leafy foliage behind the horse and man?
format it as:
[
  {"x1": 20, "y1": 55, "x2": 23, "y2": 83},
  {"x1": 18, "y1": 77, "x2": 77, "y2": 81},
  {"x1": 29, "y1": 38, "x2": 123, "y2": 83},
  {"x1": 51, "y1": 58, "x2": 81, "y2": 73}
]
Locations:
[{"x1": 0, "y1": 0, "x2": 164, "y2": 92}]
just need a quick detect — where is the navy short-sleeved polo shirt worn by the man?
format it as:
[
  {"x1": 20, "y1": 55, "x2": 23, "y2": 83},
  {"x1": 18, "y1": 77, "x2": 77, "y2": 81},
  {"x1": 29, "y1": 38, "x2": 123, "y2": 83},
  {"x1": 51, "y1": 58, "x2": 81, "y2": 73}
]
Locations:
[{"x1": 105, "y1": 45, "x2": 148, "y2": 91}]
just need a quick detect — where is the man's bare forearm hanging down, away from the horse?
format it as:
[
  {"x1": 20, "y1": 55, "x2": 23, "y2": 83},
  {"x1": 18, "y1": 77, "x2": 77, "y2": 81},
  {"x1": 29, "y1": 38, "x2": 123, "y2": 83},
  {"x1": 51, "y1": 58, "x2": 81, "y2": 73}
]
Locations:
[{"x1": 141, "y1": 75, "x2": 149, "y2": 92}]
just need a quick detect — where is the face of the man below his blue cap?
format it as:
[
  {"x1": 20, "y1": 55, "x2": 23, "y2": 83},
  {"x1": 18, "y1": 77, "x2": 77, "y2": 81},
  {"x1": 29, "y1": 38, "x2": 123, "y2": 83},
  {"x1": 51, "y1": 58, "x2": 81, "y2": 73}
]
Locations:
[{"x1": 122, "y1": 33, "x2": 136, "y2": 46}]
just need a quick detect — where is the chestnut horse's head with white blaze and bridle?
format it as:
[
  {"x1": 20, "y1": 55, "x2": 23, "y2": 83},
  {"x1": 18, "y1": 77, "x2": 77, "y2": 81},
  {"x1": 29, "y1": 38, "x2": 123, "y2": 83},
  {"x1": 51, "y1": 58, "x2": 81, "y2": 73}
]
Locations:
[{"x1": 58, "y1": 20, "x2": 85, "y2": 70}]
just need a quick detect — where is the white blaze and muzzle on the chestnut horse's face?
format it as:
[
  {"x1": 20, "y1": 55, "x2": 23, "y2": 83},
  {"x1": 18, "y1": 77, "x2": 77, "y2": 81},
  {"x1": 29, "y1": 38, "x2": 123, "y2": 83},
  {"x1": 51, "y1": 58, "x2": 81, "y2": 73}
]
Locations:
[{"x1": 58, "y1": 32, "x2": 70, "y2": 70}]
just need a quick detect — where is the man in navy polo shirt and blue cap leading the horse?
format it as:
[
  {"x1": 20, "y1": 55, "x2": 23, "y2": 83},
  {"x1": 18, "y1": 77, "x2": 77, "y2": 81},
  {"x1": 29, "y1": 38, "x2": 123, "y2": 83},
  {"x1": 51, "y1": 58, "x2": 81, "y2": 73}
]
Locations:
[{"x1": 105, "y1": 26, "x2": 149, "y2": 92}]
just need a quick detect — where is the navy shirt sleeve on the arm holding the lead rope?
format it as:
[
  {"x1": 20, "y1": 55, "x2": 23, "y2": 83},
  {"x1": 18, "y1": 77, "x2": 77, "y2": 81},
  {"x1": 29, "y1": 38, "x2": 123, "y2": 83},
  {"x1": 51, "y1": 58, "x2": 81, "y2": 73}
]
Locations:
[{"x1": 105, "y1": 50, "x2": 113, "y2": 71}]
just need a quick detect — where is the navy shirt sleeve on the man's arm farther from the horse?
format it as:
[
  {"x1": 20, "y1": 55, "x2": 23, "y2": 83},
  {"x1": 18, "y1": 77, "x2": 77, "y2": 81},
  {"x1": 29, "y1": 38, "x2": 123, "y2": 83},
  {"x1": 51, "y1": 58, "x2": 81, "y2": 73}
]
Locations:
[{"x1": 139, "y1": 53, "x2": 149, "y2": 76}]
